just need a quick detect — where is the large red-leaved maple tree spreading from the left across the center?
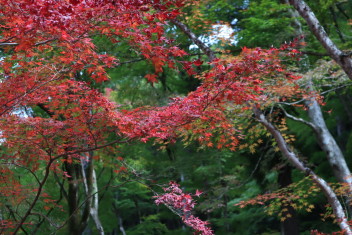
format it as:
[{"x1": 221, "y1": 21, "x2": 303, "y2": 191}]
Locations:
[{"x1": 0, "y1": 0, "x2": 349, "y2": 234}]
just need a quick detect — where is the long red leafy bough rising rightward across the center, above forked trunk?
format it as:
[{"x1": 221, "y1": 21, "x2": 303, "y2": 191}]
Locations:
[{"x1": 117, "y1": 48, "x2": 299, "y2": 150}]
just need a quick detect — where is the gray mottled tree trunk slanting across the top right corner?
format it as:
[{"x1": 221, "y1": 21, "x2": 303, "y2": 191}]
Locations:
[{"x1": 289, "y1": 0, "x2": 352, "y2": 80}]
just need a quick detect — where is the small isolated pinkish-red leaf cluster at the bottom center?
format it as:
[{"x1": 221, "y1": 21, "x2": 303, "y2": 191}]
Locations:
[{"x1": 155, "y1": 182, "x2": 214, "y2": 235}]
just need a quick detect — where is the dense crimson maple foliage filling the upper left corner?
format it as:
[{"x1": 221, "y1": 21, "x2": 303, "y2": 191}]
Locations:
[{"x1": 0, "y1": 0, "x2": 185, "y2": 114}]
